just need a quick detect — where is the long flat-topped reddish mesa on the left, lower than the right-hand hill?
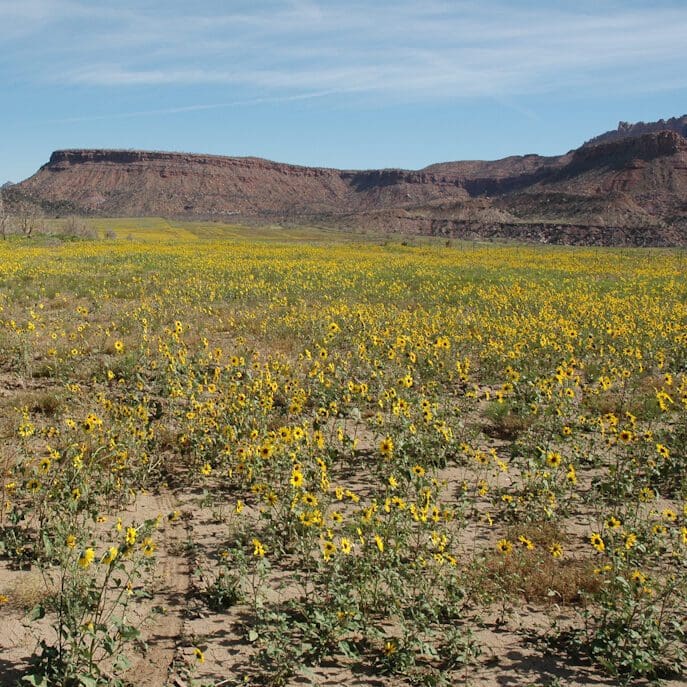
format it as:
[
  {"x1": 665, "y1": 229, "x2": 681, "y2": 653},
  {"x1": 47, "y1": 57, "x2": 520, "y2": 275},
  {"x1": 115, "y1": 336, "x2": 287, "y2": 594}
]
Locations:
[{"x1": 22, "y1": 150, "x2": 478, "y2": 217}]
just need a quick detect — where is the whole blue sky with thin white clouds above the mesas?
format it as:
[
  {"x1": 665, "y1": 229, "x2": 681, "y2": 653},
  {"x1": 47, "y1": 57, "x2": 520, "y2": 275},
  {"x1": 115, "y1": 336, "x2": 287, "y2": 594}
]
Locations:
[{"x1": 0, "y1": 0, "x2": 687, "y2": 183}]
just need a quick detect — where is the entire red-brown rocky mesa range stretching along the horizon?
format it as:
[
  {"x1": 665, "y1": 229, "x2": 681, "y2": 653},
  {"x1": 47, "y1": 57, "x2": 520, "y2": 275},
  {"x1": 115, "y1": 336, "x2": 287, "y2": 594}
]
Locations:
[{"x1": 12, "y1": 116, "x2": 687, "y2": 245}]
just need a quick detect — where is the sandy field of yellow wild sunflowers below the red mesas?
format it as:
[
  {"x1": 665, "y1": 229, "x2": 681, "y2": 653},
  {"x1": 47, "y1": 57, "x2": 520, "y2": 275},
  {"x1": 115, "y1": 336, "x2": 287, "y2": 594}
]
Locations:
[{"x1": 0, "y1": 227, "x2": 687, "y2": 687}]
